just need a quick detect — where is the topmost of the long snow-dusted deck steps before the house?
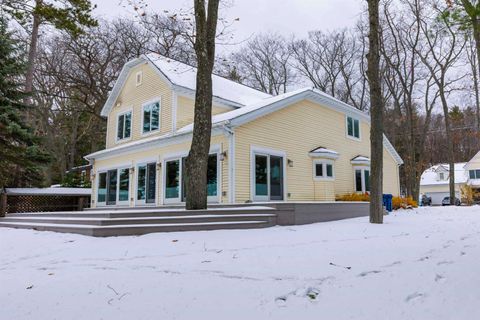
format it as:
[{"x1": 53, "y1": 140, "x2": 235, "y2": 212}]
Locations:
[{"x1": 7, "y1": 206, "x2": 276, "y2": 218}]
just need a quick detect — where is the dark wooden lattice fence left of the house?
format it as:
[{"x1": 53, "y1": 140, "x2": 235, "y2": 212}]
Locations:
[{"x1": 0, "y1": 189, "x2": 90, "y2": 216}]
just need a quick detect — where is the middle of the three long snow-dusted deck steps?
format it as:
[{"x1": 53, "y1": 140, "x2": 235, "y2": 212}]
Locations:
[{"x1": 0, "y1": 213, "x2": 276, "y2": 226}]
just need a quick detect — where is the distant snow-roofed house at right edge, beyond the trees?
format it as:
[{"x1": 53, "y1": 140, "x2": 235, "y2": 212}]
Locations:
[{"x1": 420, "y1": 152, "x2": 480, "y2": 205}]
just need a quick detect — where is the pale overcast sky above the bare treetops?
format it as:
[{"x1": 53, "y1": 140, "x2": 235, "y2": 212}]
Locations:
[{"x1": 92, "y1": 0, "x2": 366, "y2": 46}]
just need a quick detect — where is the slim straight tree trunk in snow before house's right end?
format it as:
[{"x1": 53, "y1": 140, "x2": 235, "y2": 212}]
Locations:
[{"x1": 367, "y1": 0, "x2": 383, "y2": 223}]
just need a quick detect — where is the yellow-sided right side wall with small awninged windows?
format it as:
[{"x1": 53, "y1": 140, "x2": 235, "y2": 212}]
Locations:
[{"x1": 235, "y1": 100, "x2": 400, "y2": 203}]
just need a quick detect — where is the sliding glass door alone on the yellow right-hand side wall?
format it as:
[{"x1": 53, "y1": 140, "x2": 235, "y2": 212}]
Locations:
[{"x1": 253, "y1": 154, "x2": 284, "y2": 201}]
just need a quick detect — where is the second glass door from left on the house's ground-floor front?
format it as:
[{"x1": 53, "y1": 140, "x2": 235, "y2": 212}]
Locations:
[{"x1": 136, "y1": 162, "x2": 157, "y2": 205}]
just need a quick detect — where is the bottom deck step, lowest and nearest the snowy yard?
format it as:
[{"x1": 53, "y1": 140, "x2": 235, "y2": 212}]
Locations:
[{"x1": 0, "y1": 220, "x2": 271, "y2": 237}]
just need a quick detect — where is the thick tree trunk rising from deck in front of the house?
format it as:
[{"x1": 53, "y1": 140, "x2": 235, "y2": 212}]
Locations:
[{"x1": 185, "y1": 0, "x2": 219, "y2": 210}]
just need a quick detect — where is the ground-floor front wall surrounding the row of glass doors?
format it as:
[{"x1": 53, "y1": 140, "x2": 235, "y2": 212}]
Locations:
[{"x1": 92, "y1": 135, "x2": 228, "y2": 207}]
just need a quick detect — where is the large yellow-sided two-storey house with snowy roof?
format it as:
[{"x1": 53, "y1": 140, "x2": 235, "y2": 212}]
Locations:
[{"x1": 85, "y1": 54, "x2": 402, "y2": 207}]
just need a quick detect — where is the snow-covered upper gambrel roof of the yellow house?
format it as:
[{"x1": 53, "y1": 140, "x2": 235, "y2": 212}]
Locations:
[{"x1": 101, "y1": 53, "x2": 272, "y2": 117}]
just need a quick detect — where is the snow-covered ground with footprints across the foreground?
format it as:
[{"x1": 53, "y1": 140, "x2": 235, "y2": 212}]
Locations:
[{"x1": 0, "y1": 207, "x2": 480, "y2": 320}]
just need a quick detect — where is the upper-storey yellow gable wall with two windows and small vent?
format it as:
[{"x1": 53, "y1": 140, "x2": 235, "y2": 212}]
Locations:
[{"x1": 106, "y1": 63, "x2": 173, "y2": 149}]
